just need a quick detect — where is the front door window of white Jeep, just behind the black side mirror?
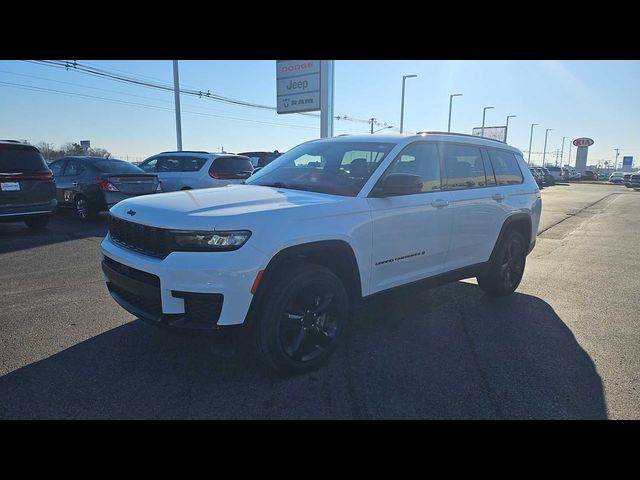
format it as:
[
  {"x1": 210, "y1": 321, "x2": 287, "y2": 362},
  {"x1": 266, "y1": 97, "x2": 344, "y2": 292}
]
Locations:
[{"x1": 385, "y1": 143, "x2": 442, "y2": 192}]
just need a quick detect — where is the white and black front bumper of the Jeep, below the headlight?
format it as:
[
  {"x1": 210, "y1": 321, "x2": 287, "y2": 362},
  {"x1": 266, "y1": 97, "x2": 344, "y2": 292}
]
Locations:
[{"x1": 101, "y1": 234, "x2": 267, "y2": 331}]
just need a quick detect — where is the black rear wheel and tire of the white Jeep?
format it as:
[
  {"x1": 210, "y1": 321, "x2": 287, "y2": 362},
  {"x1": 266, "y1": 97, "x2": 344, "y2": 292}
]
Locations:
[{"x1": 476, "y1": 230, "x2": 527, "y2": 297}]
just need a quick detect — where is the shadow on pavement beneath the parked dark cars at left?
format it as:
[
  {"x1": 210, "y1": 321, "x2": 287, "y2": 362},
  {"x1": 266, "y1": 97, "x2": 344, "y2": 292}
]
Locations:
[{"x1": 0, "y1": 208, "x2": 108, "y2": 254}]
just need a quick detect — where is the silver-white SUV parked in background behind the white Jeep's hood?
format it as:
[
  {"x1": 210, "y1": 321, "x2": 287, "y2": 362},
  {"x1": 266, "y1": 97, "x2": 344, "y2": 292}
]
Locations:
[{"x1": 139, "y1": 151, "x2": 253, "y2": 192}]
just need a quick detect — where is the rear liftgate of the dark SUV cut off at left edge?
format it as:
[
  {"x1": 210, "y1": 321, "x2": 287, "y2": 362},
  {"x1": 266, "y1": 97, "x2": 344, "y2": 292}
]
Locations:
[{"x1": 0, "y1": 144, "x2": 55, "y2": 207}]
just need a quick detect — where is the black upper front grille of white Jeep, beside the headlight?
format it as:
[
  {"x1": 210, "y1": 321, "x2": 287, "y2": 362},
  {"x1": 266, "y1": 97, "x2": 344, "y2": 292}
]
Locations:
[{"x1": 109, "y1": 215, "x2": 170, "y2": 258}]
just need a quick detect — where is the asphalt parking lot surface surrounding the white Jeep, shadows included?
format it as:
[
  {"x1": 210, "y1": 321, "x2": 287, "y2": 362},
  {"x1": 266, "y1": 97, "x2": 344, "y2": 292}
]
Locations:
[{"x1": 0, "y1": 184, "x2": 640, "y2": 419}]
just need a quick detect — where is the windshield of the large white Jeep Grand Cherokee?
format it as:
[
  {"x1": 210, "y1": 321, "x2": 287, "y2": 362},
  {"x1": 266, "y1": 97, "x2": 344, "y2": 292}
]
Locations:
[{"x1": 246, "y1": 140, "x2": 395, "y2": 197}]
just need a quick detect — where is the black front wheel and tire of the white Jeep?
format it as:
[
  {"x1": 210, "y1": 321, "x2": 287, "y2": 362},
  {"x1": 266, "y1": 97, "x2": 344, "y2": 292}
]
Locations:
[{"x1": 254, "y1": 263, "x2": 349, "y2": 374}]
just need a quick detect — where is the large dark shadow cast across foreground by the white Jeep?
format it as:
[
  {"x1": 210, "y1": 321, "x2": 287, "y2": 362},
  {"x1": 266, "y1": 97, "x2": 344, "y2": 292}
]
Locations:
[{"x1": 0, "y1": 282, "x2": 607, "y2": 419}]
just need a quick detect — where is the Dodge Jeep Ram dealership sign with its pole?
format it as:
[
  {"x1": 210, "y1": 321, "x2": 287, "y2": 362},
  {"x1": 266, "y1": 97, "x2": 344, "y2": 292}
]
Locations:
[{"x1": 276, "y1": 60, "x2": 334, "y2": 138}]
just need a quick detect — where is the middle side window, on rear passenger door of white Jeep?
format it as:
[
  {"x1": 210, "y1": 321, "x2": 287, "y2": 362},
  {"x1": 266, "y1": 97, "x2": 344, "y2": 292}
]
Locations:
[{"x1": 442, "y1": 144, "x2": 487, "y2": 190}]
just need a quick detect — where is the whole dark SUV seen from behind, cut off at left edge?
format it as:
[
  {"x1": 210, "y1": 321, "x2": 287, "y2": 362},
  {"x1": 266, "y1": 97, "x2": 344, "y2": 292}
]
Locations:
[{"x1": 0, "y1": 140, "x2": 57, "y2": 228}]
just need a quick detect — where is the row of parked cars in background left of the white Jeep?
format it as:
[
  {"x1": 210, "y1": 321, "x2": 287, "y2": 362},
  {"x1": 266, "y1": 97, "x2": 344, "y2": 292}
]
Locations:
[{"x1": 0, "y1": 140, "x2": 280, "y2": 228}]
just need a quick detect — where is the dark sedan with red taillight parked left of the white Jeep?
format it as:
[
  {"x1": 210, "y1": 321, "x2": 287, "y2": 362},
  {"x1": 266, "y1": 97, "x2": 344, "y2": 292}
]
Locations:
[{"x1": 49, "y1": 157, "x2": 162, "y2": 221}]
